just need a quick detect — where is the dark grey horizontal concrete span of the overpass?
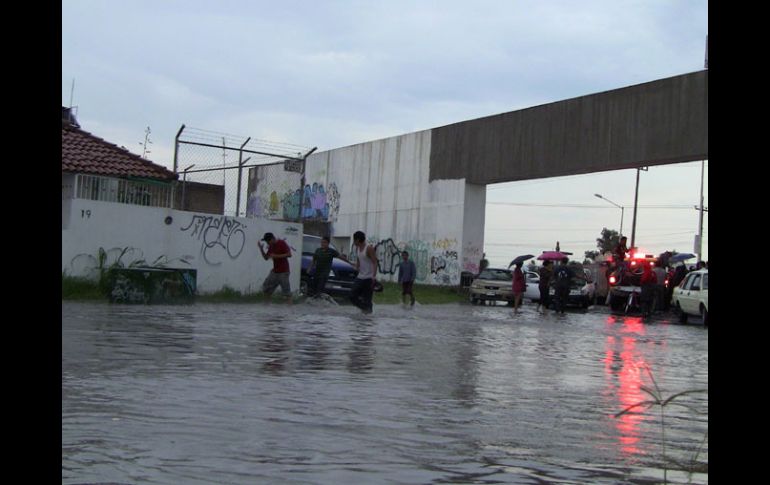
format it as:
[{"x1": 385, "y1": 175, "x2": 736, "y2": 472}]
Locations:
[{"x1": 430, "y1": 70, "x2": 708, "y2": 185}]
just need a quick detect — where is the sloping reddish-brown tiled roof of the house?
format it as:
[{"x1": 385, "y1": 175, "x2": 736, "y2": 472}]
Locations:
[{"x1": 61, "y1": 120, "x2": 178, "y2": 180}]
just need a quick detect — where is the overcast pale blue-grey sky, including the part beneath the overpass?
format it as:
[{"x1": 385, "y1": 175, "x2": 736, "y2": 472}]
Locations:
[{"x1": 61, "y1": 0, "x2": 708, "y2": 266}]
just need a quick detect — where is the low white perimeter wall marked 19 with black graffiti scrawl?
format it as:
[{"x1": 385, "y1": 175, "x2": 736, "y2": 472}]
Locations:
[{"x1": 62, "y1": 198, "x2": 302, "y2": 294}]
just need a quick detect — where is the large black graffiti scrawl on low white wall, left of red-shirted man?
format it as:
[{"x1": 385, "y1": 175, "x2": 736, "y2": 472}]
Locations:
[{"x1": 181, "y1": 215, "x2": 246, "y2": 266}]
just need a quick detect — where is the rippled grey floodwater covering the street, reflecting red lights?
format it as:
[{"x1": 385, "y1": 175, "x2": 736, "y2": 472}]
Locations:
[{"x1": 62, "y1": 295, "x2": 708, "y2": 484}]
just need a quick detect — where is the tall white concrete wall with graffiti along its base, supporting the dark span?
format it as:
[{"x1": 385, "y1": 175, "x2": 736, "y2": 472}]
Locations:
[{"x1": 306, "y1": 130, "x2": 486, "y2": 285}]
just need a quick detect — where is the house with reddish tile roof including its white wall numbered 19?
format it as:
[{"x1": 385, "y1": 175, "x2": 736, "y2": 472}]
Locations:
[{"x1": 61, "y1": 108, "x2": 302, "y2": 298}]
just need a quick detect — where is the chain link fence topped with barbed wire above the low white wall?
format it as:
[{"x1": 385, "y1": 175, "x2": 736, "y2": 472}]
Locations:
[{"x1": 174, "y1": 125, "x2": 315, "y2": 222}]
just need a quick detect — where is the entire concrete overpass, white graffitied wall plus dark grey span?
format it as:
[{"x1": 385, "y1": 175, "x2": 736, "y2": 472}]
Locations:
[{"x1": 248, "y1": 71, "x2": 708, "y2": 284}]
